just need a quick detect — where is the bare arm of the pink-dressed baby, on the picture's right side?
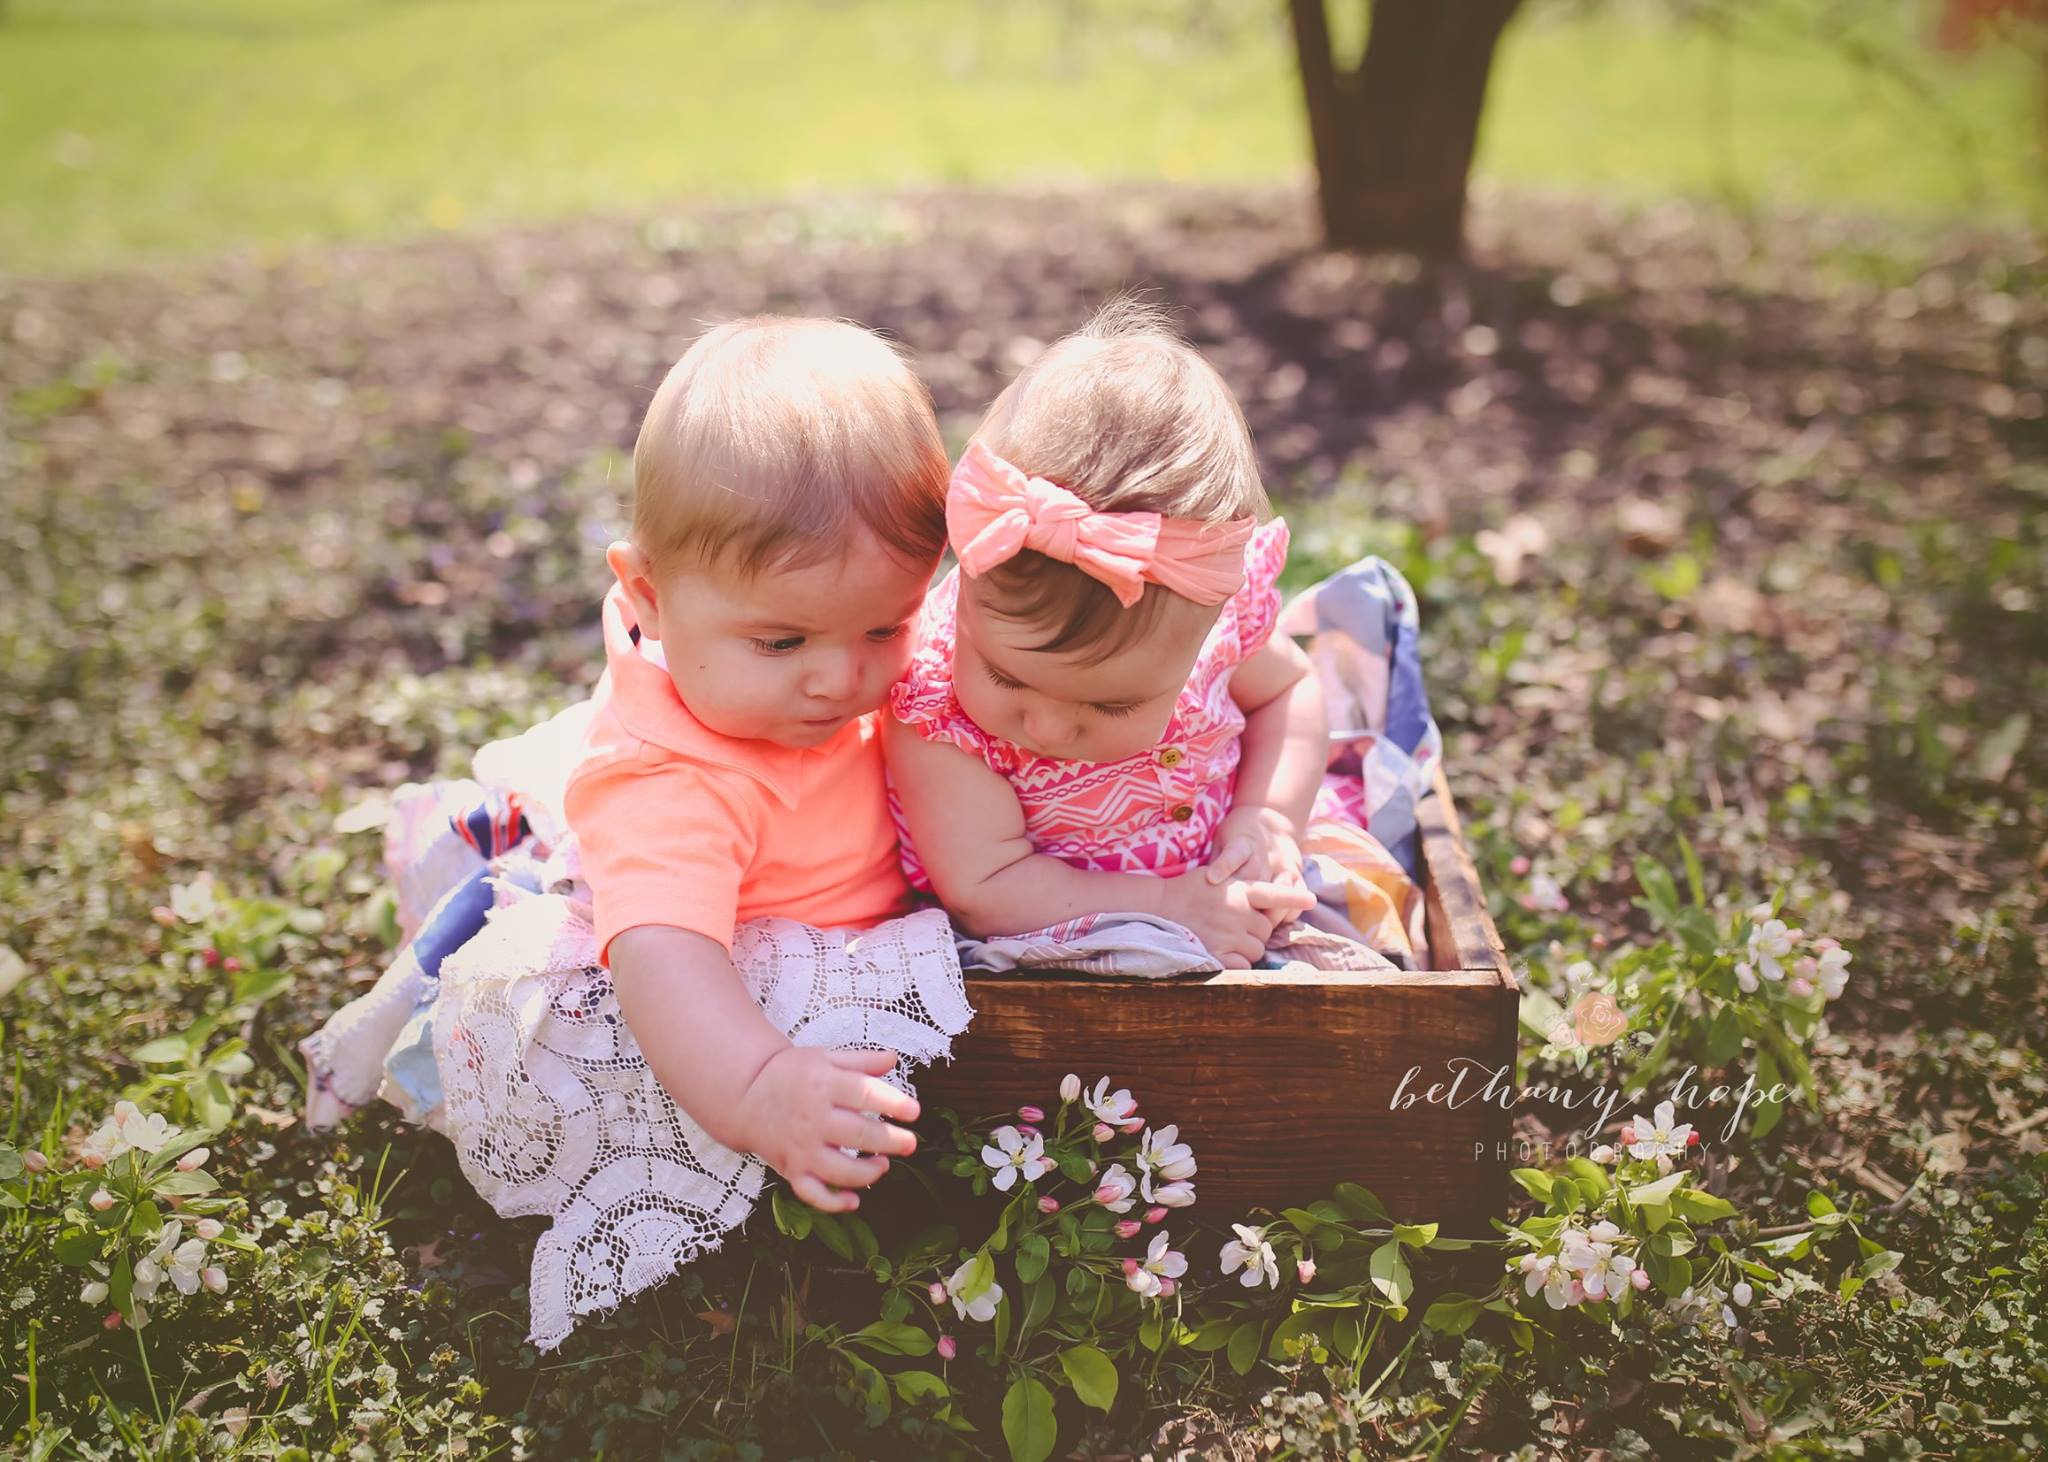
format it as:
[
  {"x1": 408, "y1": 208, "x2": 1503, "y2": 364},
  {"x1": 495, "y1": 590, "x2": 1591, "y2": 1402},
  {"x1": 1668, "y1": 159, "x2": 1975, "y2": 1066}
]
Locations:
[{"x1": 1208, "y1": 635, "x2": 1329, "y2": 885}]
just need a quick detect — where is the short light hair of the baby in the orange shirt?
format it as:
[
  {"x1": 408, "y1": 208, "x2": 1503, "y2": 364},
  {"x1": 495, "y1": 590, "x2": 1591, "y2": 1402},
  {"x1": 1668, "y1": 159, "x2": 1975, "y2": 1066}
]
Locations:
[{"x1": 633, "y1": 315, "x2": 948, "y2": 575}]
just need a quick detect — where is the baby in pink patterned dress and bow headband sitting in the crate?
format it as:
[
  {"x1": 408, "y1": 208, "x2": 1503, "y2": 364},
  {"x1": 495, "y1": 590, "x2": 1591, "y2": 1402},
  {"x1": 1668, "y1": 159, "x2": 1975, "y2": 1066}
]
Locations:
[{"x1": 883, "y1": 303, "x2": 1329, "y2": 969}]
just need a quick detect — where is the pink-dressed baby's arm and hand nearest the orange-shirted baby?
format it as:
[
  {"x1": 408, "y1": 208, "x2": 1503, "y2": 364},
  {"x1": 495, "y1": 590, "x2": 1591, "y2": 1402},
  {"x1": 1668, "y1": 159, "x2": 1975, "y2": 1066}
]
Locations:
[{"x1": 883, "y1": 715, "x2": 1307, "y2": 969}]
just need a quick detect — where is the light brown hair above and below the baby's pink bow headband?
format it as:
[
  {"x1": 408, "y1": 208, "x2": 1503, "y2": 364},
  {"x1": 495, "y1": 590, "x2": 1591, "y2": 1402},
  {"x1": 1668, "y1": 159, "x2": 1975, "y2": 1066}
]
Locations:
[{"x1": 975, "y1": 297, "x2": 1272, "y2": 659}]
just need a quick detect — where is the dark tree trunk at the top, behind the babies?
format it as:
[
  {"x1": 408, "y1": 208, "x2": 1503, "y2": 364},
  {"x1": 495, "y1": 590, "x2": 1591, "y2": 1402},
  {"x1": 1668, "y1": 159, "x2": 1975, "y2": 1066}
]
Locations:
[{"x1": 1288, "y1": 0, "x2": 1522, "y2": 256}]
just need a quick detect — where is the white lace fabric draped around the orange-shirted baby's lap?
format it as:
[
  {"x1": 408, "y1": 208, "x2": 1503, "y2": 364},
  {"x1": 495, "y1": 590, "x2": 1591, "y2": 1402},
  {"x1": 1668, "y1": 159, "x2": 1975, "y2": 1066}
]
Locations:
[{"x1": 434, "y1": 893, "x2": 973, "y2": 1351}]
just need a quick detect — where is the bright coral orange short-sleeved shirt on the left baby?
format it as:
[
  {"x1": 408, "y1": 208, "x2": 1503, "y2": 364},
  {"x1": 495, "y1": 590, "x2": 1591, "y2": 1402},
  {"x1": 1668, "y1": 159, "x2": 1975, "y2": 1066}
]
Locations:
[{"x1": 563, "y1": 586, "x2": 909, "y2": 964}]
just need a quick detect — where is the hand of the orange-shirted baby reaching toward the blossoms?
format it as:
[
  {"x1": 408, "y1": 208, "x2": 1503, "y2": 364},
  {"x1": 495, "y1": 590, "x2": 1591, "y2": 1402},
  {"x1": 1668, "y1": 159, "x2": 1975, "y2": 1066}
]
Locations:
[{"x1": 733, "y1": 1046, "x2": 918, "y2": 1212}]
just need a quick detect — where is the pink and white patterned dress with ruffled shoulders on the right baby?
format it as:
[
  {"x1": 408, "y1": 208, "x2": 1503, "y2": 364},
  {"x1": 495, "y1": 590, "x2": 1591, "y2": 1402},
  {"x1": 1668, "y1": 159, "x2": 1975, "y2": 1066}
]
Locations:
[{"x1": 889, "y1": 518, "x2": 1288, "y2": 893}]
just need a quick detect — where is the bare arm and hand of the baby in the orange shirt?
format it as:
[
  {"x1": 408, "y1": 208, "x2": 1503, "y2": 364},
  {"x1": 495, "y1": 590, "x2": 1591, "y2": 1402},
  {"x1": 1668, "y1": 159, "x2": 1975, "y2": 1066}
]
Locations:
[{"x1": 610, "y1": 923, "x2": 918, "y2": 1212}]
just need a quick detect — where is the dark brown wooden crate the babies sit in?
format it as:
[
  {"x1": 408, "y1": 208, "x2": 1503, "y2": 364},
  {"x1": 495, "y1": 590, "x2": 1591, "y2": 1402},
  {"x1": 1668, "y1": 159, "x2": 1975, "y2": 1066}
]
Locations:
[{"x1": 918, "y1": 772, "x2": 1518, "y2": 1235}]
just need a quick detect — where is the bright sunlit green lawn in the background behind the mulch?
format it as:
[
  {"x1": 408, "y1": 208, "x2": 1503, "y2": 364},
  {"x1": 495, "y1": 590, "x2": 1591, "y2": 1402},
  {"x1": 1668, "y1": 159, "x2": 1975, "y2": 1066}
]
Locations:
[{"x1": 0, "y1": 0, "x2": 2040, "y2": 272}]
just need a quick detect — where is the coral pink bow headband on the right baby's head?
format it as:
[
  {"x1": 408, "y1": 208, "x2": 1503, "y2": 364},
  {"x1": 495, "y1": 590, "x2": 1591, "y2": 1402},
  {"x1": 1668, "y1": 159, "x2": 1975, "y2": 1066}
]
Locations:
[{"x1": 946, "y1": 440, "x2": 1253, "y2": 608}]
